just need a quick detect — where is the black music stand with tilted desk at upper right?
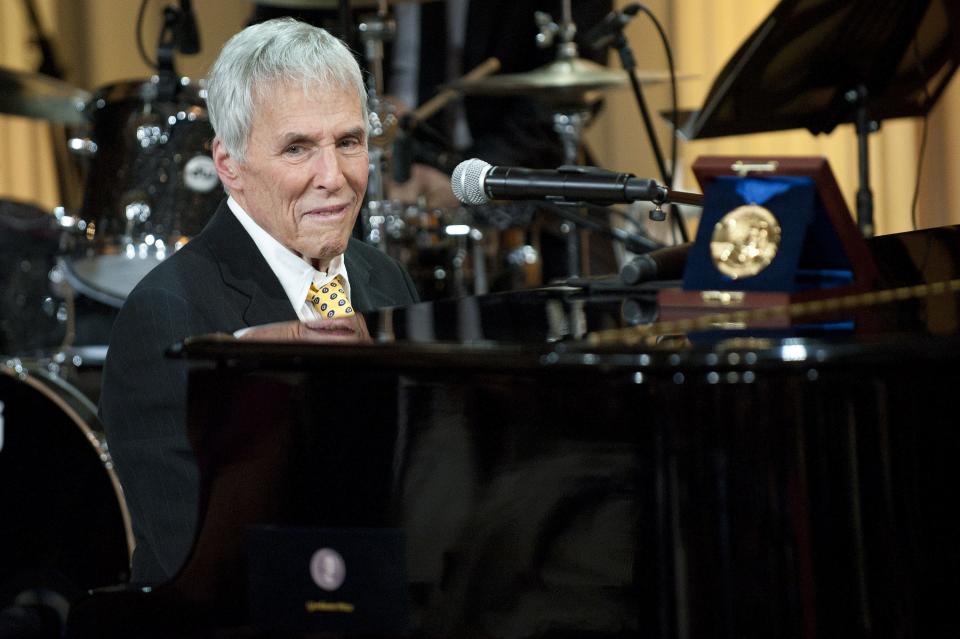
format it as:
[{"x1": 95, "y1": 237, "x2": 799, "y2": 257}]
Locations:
[{"x1": 678, "y1": 0, "x2": 960, "y2": 236}]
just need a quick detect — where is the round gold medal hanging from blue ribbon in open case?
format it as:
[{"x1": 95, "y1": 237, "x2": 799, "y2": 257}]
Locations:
[{"x1": 710, "y1": 204, "x2": 780, "y2": 279}]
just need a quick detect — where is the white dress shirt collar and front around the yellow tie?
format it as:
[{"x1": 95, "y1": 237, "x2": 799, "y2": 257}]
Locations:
[{"x1": 227, "y1": 197, "x2": 350, "y2": 321}]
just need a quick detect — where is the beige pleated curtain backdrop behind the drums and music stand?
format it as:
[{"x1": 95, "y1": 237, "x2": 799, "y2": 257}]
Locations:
[{"x1": 0, "y1": 0, "x2": 960, "y2": 238}]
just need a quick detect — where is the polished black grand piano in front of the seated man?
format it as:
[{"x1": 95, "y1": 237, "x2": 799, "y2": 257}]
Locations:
[{"x1": 71, "y1": 228, "x2": 960, "y2": 638}]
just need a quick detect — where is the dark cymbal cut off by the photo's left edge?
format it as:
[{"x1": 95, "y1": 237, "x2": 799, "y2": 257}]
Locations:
[{"x1": 0, "y1": 67, "x2": 90, "y2": 124}]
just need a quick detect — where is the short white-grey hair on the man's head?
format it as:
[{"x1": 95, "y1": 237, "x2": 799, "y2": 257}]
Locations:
[{"x1": 207, "y1": 18, "x2": 367, "y2": 162}]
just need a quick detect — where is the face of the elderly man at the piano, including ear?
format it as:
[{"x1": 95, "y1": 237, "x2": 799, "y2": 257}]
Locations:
[{"x1": 214, "y1": 83, "x2": 368, "y2": 270}]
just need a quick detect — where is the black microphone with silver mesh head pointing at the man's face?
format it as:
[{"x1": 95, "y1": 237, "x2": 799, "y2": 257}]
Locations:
[{"x1": 450, "y1": 158, "x2": 667, "y2": 206}]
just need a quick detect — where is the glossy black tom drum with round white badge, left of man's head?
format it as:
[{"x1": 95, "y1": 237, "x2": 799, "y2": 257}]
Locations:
[{"x1": 66, "y1": 78, "x2": 224, "y2": 307}]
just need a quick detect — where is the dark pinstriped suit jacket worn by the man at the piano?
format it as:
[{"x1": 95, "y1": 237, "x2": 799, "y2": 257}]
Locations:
[{"x1": 100, "y1": 201, "x2": 417, "y2": 583}]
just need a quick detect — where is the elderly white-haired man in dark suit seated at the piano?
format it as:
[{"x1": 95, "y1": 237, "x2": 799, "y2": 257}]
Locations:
[{"x1": 100, "y1": 19, "x2": 417, "y2": 583}]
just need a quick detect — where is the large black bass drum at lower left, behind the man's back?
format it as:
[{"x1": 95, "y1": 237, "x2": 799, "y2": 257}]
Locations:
[{"x1": 0, "y1": 360, "x2": 133, "y2": 608}]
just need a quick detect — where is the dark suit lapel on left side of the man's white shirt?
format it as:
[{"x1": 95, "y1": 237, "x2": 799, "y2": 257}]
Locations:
[{"x1": 201, "y1": 200, "x2": 297, "y2": 326}]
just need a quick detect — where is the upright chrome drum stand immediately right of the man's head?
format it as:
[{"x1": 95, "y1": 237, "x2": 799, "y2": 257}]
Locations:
[{"x1": 357, "y1": 0, "x2": 397, "y2": 250}]
